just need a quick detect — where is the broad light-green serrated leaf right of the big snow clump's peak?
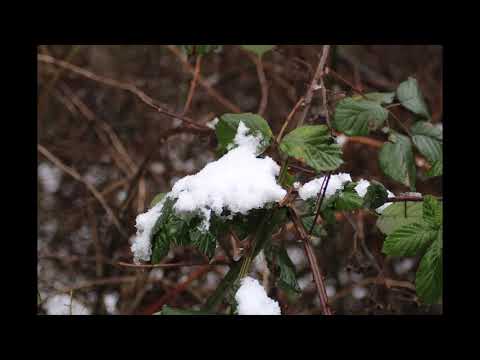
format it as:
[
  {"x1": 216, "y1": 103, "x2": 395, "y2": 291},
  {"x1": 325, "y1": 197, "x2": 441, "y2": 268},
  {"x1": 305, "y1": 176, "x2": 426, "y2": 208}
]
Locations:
[{"x1": 280, "y1": 125, "x2": 343, "y2": 172}]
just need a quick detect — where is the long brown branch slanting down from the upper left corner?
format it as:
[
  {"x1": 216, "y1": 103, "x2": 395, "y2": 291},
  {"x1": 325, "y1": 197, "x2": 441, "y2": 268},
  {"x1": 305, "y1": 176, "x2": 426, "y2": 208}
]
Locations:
[{"x1": 37, "y1": 54, "x2": 211, "y2": 130}]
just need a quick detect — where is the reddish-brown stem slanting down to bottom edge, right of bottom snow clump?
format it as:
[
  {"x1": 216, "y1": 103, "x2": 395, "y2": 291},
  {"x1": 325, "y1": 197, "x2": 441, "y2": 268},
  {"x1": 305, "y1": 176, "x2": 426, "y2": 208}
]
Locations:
[{"x1": 288, "y1": 207, "x2": 332, "y2": 315}]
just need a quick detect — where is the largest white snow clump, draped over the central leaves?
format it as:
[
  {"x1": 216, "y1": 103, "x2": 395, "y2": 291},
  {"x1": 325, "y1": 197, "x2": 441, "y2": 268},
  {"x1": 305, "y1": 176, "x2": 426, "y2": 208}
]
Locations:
[{"x1": 132, "y1": 122, "x2": 287, "y2": 261}]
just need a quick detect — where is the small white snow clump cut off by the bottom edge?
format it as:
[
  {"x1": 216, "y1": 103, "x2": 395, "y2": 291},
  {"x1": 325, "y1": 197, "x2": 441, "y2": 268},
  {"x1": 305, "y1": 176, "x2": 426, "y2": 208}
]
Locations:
[{"x1": 235, "y1": 276, "x2": 281, "y2": 315}]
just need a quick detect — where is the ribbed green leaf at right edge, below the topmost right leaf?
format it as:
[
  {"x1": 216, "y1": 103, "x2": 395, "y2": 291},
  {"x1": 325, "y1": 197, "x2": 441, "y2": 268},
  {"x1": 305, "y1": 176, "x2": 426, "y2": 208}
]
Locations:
[{"x1": 410, "y1": 121, "x2": 443, "y2": 163}]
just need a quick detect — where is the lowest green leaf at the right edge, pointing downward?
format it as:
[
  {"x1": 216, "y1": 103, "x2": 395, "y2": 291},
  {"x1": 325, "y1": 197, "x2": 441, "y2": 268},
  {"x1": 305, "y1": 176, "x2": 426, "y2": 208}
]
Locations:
[{"x1": 415, "y1": 230, "x2": 443, "y2": 304}]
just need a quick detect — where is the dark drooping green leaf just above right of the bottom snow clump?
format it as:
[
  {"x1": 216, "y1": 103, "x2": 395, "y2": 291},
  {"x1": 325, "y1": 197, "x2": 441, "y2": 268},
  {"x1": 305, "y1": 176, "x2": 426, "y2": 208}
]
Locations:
[{"x1": 264, "y1": 245, "x2": 301, "y2": 294}]
